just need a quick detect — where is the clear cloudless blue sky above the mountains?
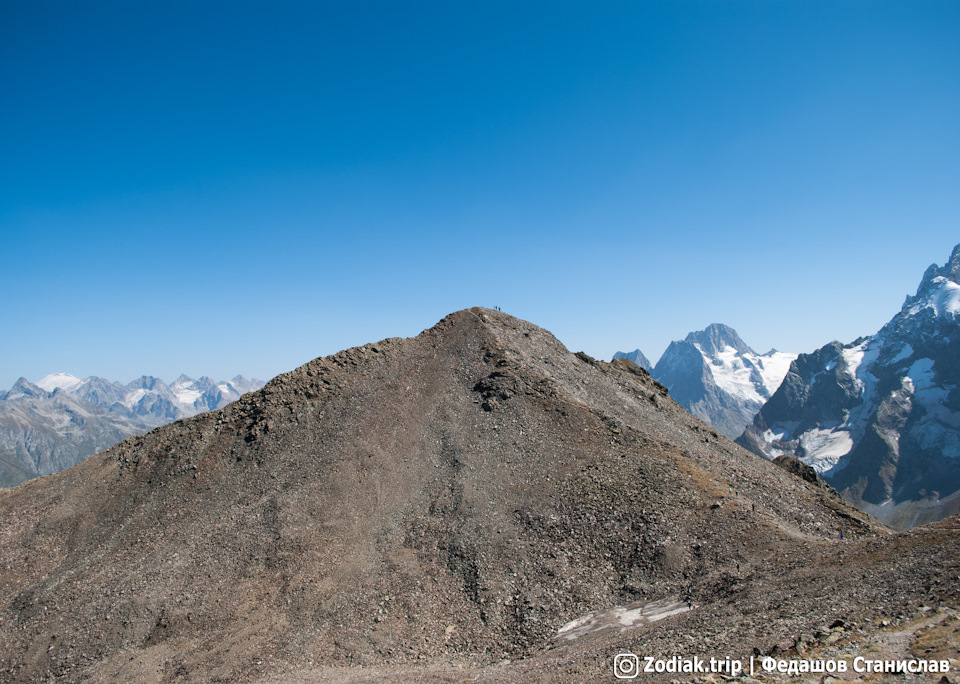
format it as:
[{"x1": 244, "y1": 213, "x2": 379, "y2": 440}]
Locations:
[{"x1": 0, "y1": 0, "x2": 960, "y2": 388}]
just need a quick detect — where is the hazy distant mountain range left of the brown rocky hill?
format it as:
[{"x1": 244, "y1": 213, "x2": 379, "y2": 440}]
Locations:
[{"x1": 0, "y1": 373, "x2": 264, "y2": 487}]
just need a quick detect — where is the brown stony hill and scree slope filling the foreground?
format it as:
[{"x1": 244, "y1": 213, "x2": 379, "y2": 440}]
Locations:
[{"x1": 0, "y1": 308, "x2": 960, "y2": 682}]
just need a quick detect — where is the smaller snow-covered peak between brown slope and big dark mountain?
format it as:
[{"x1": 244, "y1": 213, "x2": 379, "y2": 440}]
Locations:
[{"x1": 650, "y1": 323, "x2": 796, "y2": 439}]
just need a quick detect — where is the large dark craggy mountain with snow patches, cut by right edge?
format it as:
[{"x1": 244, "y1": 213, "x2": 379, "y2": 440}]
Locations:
[{"x1": 738, "y1": 245, "x2": 960, "y2": 528}]
